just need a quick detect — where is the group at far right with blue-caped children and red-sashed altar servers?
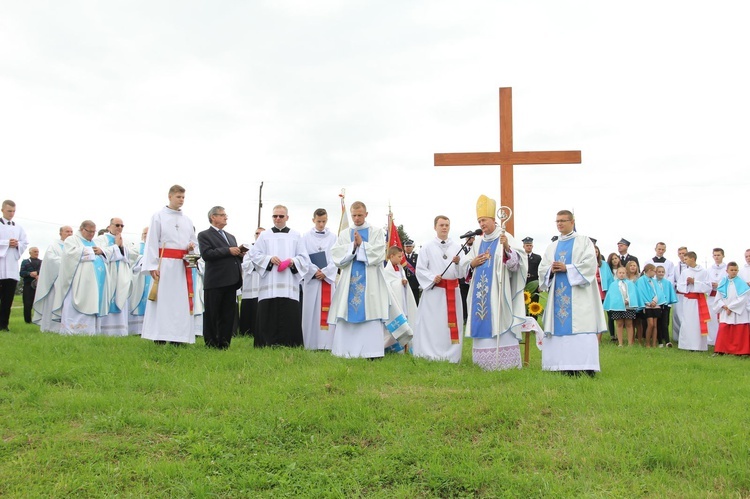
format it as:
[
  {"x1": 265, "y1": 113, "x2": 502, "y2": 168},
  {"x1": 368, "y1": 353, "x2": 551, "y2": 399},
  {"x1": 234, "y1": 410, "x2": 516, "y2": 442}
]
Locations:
[{"x1": 596, "y1": 239, "x2": 750, "y2": 355}]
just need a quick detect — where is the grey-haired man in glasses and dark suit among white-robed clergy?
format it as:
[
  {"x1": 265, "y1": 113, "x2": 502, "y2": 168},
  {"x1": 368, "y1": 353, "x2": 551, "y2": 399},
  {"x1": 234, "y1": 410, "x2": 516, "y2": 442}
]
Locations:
[{"x1": 198, "y1": 206, "x2": 247, "y2": 350}]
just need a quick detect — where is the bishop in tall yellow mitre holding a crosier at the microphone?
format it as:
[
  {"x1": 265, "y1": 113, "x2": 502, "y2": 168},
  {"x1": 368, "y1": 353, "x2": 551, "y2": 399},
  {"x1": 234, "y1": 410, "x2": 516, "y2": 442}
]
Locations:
[{"x1": 460, "y1": 195, "x2": 528, "y2": 370}]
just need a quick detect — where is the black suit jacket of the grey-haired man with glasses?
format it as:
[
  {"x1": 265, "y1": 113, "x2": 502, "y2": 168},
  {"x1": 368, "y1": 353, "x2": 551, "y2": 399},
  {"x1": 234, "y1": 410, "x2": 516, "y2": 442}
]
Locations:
[{"x1": 198, "y1": 227, "x2": 242, "y2": 289}]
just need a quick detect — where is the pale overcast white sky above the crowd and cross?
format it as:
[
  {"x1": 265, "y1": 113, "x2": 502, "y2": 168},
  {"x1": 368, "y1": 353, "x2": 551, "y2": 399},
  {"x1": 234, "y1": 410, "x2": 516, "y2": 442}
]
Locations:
[{"x1": 0, "y1": 0, "x2": 750, "y2": 270}]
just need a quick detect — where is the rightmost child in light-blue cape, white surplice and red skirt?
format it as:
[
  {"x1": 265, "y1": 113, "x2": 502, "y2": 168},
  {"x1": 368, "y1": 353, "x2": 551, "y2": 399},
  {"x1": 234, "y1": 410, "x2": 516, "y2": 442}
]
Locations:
[{"x1": 713, "y1": 262, "x2": 750, "y2": 355}]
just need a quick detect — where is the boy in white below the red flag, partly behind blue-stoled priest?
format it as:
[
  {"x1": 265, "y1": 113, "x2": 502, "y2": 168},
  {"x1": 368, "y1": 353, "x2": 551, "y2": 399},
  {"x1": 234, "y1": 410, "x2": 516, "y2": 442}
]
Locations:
[{"x1": 382, "y1": 246, "x2": 419, "y2": 353}]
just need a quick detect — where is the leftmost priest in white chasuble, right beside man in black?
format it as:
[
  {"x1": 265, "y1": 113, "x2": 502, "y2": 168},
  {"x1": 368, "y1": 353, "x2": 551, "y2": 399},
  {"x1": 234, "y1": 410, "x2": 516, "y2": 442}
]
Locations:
[{"x1": 31, "y1": 225, "x2": 73, "y2": 333}]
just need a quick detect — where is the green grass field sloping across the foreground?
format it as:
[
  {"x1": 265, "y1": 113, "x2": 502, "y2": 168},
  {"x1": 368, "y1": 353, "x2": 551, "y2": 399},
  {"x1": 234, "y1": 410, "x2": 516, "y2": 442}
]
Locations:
[{"x1": 0, "y1": 304, "x2": 750, "y2": 498}]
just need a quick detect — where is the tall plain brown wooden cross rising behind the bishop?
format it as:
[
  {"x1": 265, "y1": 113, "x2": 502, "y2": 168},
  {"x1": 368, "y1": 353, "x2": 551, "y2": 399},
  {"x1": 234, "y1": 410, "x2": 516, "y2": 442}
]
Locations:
[{"x1": 435, "y1": 87, "x2": 581, "y2": 235}]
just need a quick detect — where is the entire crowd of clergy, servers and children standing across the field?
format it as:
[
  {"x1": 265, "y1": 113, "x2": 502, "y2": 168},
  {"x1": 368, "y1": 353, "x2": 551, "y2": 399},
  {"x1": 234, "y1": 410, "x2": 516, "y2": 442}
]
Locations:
[{"x1": 0, "y1": 190, "x2": 750, "y2": 375}]
